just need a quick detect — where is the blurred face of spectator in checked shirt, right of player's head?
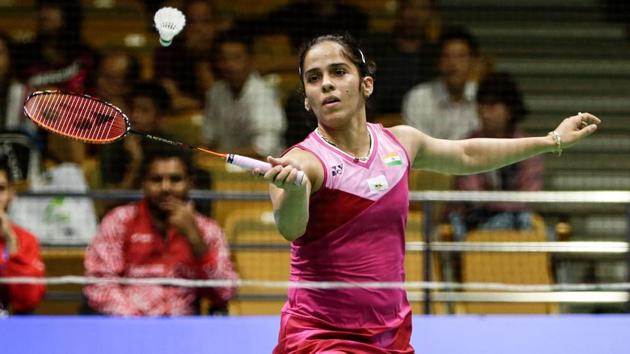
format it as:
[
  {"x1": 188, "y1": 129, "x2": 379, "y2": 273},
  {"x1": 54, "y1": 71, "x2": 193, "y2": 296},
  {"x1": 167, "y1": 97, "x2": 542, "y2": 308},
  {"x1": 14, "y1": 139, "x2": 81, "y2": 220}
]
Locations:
[{"x1": 440, "y1": 40, "x2": 474, "y2": 90}]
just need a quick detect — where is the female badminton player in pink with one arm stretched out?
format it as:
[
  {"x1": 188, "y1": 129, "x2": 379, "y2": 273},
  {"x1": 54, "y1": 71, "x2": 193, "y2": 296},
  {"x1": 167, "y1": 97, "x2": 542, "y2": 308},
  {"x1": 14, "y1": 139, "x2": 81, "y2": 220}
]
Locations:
[{"x1": 264, "y1": 35, "x2": 600, "y2": 354}]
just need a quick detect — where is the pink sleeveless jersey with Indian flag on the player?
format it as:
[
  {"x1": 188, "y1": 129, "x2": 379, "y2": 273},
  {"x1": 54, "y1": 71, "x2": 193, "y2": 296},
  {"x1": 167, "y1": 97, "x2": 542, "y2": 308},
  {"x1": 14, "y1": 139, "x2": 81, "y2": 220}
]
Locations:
[{"x1": 277, "y1": 124, "x2": 418, "y2": 353}]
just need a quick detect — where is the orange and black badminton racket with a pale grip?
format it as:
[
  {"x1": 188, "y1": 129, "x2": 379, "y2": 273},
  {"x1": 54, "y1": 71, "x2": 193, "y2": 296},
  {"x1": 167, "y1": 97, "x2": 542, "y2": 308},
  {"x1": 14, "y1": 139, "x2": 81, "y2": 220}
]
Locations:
[{"x1": 24, "y1": 91, "x2": 304, "y2": 185}]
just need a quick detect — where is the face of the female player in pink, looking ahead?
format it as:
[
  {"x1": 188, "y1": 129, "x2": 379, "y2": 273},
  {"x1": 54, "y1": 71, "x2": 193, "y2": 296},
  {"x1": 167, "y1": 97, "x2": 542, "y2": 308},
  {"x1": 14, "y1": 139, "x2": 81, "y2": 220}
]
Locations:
[{"x1": 302, "y1": 41, "x2": 373, "y2": 127}]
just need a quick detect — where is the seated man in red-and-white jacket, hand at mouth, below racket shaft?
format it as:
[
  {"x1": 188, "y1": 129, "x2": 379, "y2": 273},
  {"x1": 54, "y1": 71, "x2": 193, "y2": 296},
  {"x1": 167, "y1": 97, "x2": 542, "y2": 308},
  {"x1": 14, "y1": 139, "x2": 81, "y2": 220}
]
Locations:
[{"x1": 85, "y1": 144, "x2": 237, "y2": 316}]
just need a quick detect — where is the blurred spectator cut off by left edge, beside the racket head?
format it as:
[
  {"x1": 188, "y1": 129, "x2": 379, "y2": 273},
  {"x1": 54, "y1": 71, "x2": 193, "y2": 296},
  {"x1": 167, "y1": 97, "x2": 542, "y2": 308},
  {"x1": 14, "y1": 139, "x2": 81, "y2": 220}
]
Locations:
[{"x1": 0, "y1": 33, "x2": 36, "y2": 136}]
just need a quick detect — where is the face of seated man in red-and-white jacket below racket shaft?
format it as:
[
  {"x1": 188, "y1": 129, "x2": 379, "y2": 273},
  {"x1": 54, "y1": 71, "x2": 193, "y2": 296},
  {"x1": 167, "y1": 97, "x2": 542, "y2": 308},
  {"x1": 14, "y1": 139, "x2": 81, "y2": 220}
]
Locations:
[{"x1": 142, "y1": 158, "x2": 191, "y2": 212}]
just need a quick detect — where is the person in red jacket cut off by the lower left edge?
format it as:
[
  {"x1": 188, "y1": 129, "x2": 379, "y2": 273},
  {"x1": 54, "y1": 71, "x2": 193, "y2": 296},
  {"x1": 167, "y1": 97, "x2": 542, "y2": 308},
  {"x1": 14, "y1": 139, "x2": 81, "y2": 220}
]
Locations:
[{"x1": 0, "y1": 157, "x2": 46, "y2": 313}]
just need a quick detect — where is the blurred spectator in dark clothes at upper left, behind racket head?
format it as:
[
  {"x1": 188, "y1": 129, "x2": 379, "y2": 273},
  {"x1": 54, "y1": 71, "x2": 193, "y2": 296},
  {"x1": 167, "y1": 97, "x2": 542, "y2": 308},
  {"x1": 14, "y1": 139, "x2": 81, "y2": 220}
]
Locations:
[{"x1": 15, "y1": 0, "x2": 96, "y2": 164}]
